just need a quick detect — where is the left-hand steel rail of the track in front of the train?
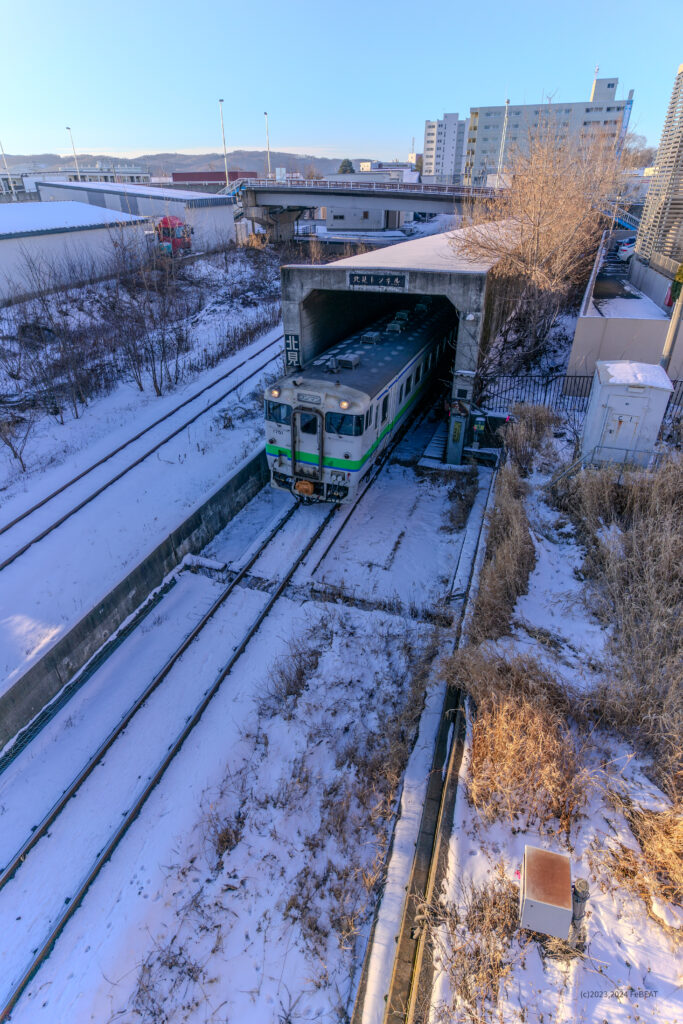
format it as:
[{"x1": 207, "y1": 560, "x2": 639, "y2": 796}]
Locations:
[{"x1": 0, "y1": 501, "x2": 301, "y2": 890}]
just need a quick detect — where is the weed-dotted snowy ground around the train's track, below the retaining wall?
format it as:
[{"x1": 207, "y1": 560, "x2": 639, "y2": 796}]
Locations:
[{"x1": 0, "y1": 411, "x2": 489, "y2": 1024}]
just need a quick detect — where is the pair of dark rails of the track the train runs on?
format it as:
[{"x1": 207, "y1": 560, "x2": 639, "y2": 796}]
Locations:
[{"x1": 0, "y1": 389, "x2": 438, "y2": 1022}]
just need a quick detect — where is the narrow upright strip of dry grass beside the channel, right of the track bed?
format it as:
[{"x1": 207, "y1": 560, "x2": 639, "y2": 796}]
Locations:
[{"x1": 469, "y1": 465, "x2": 536, "y2": 644}]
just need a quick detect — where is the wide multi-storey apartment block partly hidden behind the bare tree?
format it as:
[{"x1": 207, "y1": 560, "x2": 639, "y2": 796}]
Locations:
[{"x1": 464, "y1": 78, "x2": 633, "y2": 185}]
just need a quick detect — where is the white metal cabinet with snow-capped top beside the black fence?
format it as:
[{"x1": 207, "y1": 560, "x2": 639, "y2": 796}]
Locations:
[{"x1": 581, "y1": 359, "x2": 674, "y2": 466}]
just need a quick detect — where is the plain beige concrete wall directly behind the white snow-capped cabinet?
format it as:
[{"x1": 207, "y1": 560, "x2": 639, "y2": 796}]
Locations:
[{"x1": 567, "y1": 316, "x2": 683, "y2": 380}]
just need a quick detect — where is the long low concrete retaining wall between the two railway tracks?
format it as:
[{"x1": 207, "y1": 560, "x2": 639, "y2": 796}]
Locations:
[{"x1": 0, "y1": 450, "x2": 268, "y2": 749}]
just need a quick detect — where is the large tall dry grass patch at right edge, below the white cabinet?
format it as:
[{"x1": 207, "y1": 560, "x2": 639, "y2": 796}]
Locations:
[{"x1": 560, "y1": 456, "x2": 683, "y2": 797}]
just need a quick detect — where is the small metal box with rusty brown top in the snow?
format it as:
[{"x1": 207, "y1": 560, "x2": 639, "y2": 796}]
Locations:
[{"x1": 519, "y1": 846, "x2": 572, "y2": 939}]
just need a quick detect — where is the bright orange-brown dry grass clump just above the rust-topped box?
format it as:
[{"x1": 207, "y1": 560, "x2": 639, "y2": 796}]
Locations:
[{"x1": 445, "y1": 647, "x2": 591, "y2": 836}]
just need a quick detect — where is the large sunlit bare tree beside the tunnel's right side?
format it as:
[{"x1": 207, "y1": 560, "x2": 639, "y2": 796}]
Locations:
[{"x1": 454, "y1": 118, "x2": 618, "y2": 361}]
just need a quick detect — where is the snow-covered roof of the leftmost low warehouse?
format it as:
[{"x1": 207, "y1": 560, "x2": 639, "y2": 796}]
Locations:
[{"x1": 0, "y1": 201, "x2": 148, "y2": 239}]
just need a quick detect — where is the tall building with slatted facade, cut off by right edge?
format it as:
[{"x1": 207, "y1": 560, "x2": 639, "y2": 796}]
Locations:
[{"x1": 636, "y1": 65, "x2": 683, "y2": 273}]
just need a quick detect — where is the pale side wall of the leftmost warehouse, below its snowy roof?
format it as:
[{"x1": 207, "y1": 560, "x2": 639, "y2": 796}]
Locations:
[{"x1": 0, "y1": 223, "x2": 152, "y2": 301}]
